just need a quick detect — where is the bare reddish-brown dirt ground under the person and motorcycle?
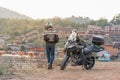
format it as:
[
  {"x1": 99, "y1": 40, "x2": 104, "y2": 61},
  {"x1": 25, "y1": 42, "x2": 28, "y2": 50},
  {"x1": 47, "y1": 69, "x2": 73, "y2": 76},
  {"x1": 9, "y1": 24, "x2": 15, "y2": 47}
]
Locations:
[{"x1": 0, "y1": 62, "x2": 120, "y2": 80}]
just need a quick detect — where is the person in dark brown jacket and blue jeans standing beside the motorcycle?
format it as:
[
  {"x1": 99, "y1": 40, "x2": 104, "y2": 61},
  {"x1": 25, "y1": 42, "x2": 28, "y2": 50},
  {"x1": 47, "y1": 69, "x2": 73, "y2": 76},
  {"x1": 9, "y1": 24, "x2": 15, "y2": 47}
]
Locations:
[{"x1": 44, "y1": 23, "x2": 59, "y2": 69}]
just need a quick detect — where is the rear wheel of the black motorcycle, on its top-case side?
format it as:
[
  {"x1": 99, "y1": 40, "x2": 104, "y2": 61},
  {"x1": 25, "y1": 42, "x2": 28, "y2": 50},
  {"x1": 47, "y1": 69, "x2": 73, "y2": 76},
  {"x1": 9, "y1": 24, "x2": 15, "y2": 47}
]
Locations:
[{"x1": 84, "y1": 56, "x2": 95, "y2": 70}]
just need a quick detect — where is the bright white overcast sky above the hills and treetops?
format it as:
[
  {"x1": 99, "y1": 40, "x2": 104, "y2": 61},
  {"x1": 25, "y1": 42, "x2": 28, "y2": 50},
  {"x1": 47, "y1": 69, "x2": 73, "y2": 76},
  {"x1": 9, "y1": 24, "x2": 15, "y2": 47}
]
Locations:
[{"x1": 0, "y1": 0, "x2": 120, "y2": 20}]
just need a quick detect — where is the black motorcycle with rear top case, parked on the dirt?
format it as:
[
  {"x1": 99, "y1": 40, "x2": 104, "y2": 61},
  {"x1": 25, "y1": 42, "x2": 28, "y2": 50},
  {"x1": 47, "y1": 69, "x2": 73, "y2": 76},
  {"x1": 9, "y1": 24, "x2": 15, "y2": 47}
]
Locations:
[{"x1": 60, "y1": 36, "x2": 104, "y2": 70}]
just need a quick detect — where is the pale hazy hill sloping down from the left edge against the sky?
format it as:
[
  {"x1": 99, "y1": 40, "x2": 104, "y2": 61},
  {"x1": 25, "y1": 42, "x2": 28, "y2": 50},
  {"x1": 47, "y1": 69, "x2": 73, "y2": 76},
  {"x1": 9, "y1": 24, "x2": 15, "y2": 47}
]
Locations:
[{"x1": 0, "y1": 7, "x2": 31, "y2": 19}]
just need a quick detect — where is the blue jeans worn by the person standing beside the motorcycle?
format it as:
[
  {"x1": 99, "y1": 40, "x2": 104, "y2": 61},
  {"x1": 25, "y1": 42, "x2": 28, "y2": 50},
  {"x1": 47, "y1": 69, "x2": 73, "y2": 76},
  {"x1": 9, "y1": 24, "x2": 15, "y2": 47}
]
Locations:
[{"x1": 46, "y1": 46, "x2": 55, "y2": 64}]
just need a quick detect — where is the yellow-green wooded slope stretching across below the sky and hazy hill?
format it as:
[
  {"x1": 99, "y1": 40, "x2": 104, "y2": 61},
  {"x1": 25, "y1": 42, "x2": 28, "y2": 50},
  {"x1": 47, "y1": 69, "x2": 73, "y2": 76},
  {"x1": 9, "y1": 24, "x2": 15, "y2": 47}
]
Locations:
[{"x1": 0, "y1": 14, "x2": 120, "y2": 46}]
